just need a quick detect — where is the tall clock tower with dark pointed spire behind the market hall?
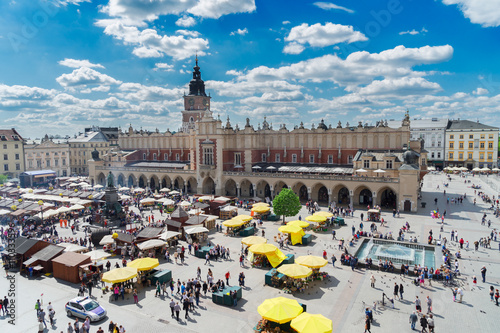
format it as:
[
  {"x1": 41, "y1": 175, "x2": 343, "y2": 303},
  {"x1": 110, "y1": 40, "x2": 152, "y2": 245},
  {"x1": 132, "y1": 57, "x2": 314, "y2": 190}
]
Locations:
[{"x1": 182, "y1": 56, "x2": 211, "y2": 132}]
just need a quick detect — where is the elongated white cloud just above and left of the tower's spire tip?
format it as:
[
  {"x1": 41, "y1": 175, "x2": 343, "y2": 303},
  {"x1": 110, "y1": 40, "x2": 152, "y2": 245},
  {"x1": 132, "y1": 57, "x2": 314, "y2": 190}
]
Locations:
[{"x1": 104, "y1": 23, "x2": 208, "y2": 60}]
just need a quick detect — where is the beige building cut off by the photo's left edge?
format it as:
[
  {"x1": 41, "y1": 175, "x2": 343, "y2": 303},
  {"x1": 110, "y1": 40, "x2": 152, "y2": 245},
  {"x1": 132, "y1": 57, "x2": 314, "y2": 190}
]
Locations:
[{"x1": 0, "y1": 128, "x2": 24, "y2": 178}]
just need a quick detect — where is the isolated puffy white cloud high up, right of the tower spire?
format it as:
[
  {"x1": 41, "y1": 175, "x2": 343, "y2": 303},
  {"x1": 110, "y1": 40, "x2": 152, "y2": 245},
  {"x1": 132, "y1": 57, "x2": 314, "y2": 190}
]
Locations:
[{"x1": 285, "y1": 22, "x2": 368, "y2": 53}]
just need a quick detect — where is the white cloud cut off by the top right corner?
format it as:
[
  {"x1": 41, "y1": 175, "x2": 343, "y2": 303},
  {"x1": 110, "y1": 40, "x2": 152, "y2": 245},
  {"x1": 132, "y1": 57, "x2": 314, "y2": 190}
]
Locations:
[{"x1": 442, "y1": 0, "x2": 500, "y2": 27}]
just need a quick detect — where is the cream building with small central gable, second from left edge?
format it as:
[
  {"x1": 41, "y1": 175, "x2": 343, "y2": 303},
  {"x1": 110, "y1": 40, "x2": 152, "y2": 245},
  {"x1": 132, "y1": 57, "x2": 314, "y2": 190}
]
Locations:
[{"x1": 24, "y1": 135, "x2": 71, "y2": 177}]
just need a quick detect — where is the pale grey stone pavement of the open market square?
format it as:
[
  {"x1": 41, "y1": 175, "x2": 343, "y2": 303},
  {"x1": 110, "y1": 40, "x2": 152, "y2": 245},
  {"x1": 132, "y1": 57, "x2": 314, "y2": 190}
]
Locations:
[{"x1": 0, "y1": 174, "x2": 500, "y2": 333}]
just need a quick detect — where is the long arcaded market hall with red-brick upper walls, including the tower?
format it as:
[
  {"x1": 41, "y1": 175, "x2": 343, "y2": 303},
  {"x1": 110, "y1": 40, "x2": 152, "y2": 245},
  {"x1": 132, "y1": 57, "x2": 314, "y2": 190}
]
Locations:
[{"x1": 89, "y1": 60, "x2": 425, "y2": 211}]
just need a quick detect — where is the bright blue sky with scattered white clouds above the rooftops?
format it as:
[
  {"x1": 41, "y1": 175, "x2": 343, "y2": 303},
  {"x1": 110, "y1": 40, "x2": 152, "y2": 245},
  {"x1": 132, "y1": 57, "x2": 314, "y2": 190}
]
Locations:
[{"x1": 0, "y1": 0, "x2": 500, "y2": 139}]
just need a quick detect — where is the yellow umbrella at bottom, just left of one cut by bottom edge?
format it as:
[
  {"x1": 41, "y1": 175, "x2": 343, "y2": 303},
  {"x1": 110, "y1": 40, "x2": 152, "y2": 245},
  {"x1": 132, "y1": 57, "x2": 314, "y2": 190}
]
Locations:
[{"x1": 257, "y1": 297, "x2": 304, "y2": 324}]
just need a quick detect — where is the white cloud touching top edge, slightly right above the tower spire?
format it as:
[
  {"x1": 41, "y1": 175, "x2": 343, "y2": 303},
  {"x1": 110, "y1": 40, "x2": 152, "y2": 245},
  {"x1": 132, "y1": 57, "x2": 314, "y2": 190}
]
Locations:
[{"x1": 187, "y1": 0, "x2": 256, "y2": 19}]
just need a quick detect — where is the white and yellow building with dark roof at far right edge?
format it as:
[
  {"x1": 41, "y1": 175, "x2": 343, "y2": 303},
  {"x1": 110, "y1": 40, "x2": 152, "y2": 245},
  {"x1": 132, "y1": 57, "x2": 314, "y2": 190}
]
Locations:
[{"x1": 445, "y1": 120, "x2": 498, "y2": 170}]
